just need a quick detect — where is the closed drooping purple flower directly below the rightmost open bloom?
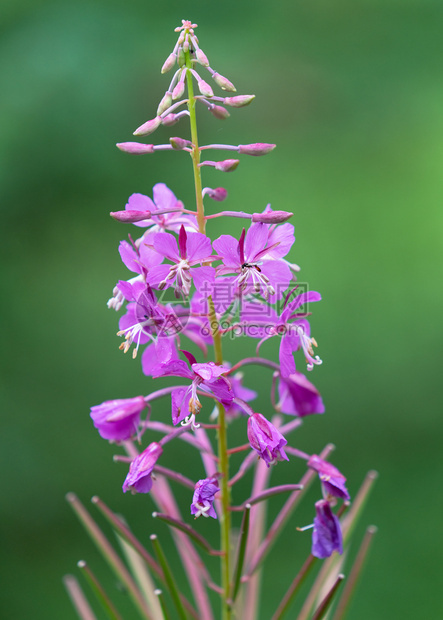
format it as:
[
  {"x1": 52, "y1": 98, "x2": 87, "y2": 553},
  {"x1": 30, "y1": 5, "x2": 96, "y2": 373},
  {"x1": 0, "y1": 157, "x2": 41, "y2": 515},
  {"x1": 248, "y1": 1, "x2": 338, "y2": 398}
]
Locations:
[{"x1": 277, "y1": 372, "x2": 325, "y2": 418}]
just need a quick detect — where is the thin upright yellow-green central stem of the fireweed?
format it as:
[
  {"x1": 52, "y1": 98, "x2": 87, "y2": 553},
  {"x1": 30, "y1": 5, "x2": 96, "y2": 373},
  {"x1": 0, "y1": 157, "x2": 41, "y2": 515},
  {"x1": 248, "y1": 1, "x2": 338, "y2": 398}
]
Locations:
[{"x1": 185, "y1": 38, "x2": 232, "y2": 620}]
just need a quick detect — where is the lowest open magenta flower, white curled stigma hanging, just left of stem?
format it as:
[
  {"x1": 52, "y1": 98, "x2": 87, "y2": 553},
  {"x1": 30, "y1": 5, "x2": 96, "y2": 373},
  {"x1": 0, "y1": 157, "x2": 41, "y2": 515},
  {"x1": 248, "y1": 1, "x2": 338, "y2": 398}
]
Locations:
[{"x1": 151, "y1": 351, "x2": 234, "y2": 428}]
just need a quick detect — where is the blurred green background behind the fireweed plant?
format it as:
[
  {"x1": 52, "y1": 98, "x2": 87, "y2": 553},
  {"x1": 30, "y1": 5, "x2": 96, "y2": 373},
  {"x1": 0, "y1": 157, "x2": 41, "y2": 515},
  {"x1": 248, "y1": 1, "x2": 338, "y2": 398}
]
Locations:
[{"x1": 0, "y1": 0, "x2": 443, "y2": 620}]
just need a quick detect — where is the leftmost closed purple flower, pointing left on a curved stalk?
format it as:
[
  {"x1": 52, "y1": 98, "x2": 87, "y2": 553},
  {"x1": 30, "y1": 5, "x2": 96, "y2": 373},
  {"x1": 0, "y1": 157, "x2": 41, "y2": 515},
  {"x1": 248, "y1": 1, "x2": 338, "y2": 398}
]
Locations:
[{"x1": 91, "y1": 396, "x2": 146, "y2": 441}]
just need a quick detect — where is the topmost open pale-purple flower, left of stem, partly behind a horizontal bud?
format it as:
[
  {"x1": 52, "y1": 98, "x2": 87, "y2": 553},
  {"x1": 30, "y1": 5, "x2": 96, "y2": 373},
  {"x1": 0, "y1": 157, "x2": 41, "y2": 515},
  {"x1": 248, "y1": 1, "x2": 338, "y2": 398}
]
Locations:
[{"x1": 125, "y1": 183, "x2": 198, "y2": 233}]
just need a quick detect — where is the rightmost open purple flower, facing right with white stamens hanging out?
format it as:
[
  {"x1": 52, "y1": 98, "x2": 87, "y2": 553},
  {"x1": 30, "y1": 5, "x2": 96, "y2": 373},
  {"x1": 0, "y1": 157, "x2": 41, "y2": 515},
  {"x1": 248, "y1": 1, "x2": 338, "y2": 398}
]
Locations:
[{"x1": 242, "y1": 291, "x2": 322, "y2": 377}]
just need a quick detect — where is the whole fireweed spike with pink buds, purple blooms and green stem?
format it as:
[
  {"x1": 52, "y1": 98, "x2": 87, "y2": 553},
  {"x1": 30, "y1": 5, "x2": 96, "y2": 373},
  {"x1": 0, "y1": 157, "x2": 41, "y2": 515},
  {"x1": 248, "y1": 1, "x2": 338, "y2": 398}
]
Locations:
[{"x1": 78, "y1": 20, "x2": 376, "y2": 620}]
